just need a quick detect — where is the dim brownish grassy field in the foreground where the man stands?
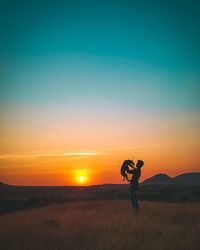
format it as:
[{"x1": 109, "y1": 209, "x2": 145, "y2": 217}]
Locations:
[{"x1": 0, "y1": 200, "x2": 200, "y2": 250}]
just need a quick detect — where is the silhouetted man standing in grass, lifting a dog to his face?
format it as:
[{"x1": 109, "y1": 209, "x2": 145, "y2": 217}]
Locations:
[{"x1": 127, "y1": 160, "x2": 144, "y2": 212}]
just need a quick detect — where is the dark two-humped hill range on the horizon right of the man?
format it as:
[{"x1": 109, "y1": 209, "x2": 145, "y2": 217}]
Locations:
[{"x1": 141, "y1": 172, "x2": 200, "y2": 186}]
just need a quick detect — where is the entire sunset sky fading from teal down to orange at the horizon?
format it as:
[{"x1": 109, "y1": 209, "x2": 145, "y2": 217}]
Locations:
[{"x1": 0, "y1": 0, "x2": 200, "y2": 185}]
